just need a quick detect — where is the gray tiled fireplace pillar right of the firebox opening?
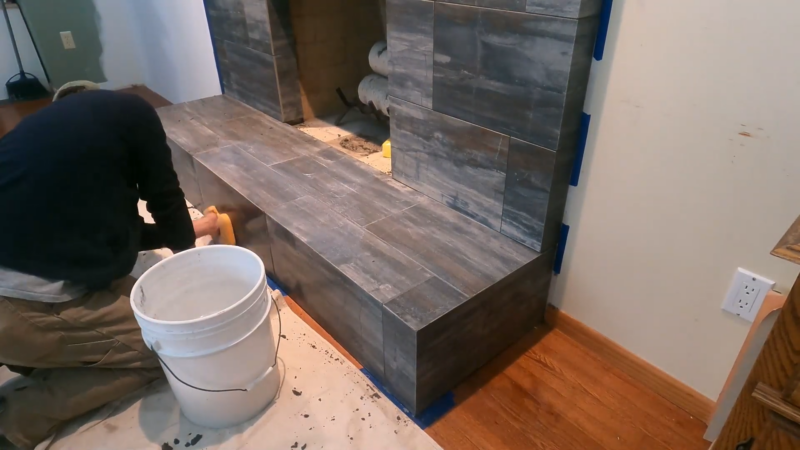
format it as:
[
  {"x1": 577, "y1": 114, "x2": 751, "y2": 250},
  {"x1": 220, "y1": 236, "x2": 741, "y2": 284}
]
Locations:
[{"x1": 387, "y1": 0, "x2": 601, "y2": 251}]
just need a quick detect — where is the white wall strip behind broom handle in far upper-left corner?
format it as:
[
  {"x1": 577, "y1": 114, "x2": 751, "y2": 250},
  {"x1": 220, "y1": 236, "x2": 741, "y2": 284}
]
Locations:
[{"x1": 0, "y1": 6, "x2": 47, "y2": 100}]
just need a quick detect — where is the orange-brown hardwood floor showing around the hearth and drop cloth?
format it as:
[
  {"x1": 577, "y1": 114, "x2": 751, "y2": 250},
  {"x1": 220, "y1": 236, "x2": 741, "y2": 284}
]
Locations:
[{"x1": 0, "y1": 87, "x2": 709, "y2": 450}]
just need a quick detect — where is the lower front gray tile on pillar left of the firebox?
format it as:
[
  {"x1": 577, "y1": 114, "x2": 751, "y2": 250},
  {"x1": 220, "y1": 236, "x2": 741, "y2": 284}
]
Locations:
[{"x1": 225, "y1": 41, "x2": 282, "y2": 120}]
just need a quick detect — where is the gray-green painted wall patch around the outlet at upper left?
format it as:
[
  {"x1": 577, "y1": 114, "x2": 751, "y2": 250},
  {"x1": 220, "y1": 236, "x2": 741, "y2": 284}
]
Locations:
[{"x1": 18, "y1": 0, "x2": 108, "y2": 88}]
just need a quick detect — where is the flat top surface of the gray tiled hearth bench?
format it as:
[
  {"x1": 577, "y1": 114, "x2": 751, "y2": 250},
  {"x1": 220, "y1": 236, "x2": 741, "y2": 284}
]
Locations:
[{"x1": 158, "y1": 95, "x2": 539, "y2": 303}]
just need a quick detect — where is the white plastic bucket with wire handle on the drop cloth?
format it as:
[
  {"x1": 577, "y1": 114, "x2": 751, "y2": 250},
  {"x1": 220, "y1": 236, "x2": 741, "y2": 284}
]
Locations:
[{"x1": 131, "y1": 245, "x2": 280, "y2": 428}]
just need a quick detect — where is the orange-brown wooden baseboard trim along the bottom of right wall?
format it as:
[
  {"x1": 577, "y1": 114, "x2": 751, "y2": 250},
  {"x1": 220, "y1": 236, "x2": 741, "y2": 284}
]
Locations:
[{"x1": 545, "y1": 305, "x2": 715, "y2": 424}]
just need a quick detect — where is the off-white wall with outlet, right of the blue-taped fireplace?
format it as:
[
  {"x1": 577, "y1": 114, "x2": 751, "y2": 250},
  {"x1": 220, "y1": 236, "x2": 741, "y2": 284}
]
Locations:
[{"x1": 551, "y1": 0, "x2": 800, "y2": 399}]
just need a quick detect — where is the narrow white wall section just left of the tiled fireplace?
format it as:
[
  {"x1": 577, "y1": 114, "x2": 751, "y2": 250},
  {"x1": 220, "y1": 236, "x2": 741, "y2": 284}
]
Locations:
[{"x1": 127, "y1": 0, "x2": 221, "y2": 103}]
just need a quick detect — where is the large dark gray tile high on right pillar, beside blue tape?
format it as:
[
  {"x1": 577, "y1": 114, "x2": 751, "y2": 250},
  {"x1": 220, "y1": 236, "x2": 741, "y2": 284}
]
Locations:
[{"x1": 433, "y1": 2, "x2": 597, "y2": 150}]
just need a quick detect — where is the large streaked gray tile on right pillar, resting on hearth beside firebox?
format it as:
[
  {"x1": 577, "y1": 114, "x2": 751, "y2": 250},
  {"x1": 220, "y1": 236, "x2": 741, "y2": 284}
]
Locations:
[{"x1": 391, "y1": 98, "x2": 508, "y2": 231}]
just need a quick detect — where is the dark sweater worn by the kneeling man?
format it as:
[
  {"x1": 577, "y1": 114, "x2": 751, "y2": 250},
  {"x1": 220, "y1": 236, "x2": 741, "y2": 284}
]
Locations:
[{"x1": 0, "y1": 91, "x2": 195, "y2": 289}]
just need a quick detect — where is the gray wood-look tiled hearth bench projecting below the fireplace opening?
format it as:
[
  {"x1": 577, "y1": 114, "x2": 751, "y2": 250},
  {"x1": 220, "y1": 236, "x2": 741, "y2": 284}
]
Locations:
[{"x1": 159, "y1": 96, "x2": 553, "y2": 413}]
